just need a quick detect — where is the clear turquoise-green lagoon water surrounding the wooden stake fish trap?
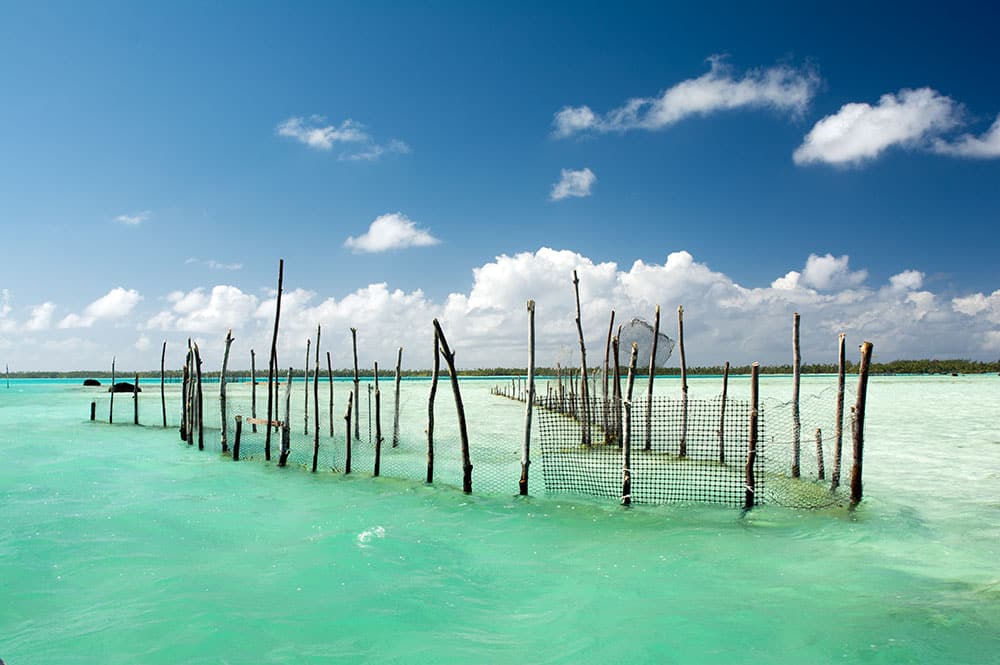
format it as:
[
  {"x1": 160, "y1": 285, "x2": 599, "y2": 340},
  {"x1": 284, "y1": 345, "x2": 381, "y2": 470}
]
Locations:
[{"x1": 0, "y1": 376, "x2": 1000, "y2": 665}]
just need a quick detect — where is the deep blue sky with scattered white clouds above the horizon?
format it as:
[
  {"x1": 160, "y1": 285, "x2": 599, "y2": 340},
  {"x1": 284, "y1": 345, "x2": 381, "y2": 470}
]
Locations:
[{"x1": 0, "y1": 3, "x2": 1000, "y2": 369}]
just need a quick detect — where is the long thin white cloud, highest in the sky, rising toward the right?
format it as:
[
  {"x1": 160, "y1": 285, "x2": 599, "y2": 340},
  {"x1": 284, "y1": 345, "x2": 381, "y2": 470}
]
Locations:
[{"x1": 552, "y1": 55, "x2": 819, "y2": 138}]
